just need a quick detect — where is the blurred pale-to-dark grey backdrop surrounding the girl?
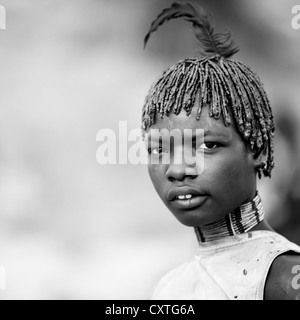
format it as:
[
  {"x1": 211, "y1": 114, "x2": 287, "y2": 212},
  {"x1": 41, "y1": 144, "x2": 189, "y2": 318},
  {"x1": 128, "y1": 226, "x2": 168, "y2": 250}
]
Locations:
[{"x1": 0, "y1": 0, "x2": 300, "y2": 299}]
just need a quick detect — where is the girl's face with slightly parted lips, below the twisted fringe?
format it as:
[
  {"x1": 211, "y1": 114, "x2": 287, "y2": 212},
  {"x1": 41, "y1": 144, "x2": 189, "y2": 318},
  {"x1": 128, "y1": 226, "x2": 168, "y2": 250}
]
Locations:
[{"x1": 147, "y1": 107, "x2": 258, "y2": 227}]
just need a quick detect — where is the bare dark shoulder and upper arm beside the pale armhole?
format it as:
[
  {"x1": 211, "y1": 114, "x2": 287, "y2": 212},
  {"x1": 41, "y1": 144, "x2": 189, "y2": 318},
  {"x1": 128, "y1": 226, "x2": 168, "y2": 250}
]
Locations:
[{"x1": 265, "y1": 252, "x2": 300, "y2": 300}]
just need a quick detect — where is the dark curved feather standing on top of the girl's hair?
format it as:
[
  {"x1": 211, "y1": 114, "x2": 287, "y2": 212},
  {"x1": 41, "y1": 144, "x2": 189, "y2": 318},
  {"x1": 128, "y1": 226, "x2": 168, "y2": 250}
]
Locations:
[{"x1": 144, "y1": 2, "x2": 239, "y2": 58}]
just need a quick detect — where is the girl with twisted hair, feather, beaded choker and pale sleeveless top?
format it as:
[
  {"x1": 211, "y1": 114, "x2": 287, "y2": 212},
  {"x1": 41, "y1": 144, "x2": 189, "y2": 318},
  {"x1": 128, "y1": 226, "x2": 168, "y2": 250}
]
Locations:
[{"x1": 142, "y1": 3, "x2": 300, "y2": 300}]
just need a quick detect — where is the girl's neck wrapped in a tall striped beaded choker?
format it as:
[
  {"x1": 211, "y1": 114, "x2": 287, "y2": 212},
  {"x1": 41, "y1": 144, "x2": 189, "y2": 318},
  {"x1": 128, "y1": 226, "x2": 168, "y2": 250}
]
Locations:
[{"x1": 195, "y1": 192, "x2": 272, "y2": 243}]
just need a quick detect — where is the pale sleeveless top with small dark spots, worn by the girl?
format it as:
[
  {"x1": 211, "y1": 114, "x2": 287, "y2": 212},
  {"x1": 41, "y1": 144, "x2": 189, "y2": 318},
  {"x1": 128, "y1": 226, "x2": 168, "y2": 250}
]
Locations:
[{"x1": 152, "y1": 231, "x2": 300, "y2": 300}]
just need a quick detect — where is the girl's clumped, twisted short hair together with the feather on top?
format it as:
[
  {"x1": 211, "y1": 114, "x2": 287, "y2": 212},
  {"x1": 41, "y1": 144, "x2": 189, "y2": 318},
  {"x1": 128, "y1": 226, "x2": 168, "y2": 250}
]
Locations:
[{"x1": 142, "y1": 3, "x2": 275, "y2": 177}]
